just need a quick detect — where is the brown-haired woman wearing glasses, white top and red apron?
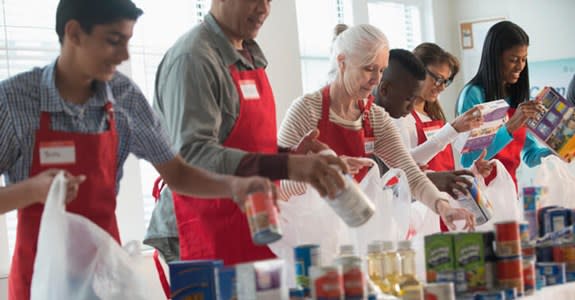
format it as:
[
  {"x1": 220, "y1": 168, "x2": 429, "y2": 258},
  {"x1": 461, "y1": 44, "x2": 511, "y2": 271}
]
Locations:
[{"x1": 396, "y1": 43, "x2": 492, "y2": 231}]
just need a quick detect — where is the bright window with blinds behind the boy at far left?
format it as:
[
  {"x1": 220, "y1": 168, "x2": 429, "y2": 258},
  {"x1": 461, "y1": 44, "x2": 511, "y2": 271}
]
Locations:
[{"x1": 0, "y1": 0, "x2": 211, "y2": 276}]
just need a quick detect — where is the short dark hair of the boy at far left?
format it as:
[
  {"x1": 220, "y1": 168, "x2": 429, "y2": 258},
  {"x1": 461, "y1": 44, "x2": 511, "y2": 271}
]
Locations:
[{"x1": 56, "y1": 0, "x2": 144, "y2": 44}]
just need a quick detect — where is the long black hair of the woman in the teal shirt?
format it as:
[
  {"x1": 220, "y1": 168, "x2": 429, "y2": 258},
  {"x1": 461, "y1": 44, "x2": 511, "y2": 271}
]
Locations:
[{"x1": 468, "y1": 21, "x2": 529, "y2": 108}]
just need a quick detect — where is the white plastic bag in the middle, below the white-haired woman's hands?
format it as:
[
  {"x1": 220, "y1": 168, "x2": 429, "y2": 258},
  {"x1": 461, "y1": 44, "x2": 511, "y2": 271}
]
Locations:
[{"x1": 269, "y1": 164, "x2": 411, "y2": 286}]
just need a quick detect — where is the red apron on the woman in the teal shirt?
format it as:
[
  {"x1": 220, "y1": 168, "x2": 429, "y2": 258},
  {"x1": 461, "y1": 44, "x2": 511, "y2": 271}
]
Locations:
[{"x1": 485, "y1": 108, "x2": 527, "y2": 189}]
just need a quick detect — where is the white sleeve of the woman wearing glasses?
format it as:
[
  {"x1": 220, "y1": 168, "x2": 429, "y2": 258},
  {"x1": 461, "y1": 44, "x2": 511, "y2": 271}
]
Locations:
[{"x1": 410, "y1": 123, "x2": 458, "y2": 165}]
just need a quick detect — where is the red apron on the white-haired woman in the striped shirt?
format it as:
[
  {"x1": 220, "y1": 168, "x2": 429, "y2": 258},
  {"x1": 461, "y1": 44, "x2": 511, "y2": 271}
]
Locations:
[{"x1": 317, "y1": 85, "x2": 375, "y2": 182}]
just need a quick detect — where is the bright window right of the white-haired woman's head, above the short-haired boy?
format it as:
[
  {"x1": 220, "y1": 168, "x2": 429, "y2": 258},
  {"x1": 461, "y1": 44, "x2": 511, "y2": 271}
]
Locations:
[{"x1": 367, "y1": 0, "x2": 422, "y2": 50}]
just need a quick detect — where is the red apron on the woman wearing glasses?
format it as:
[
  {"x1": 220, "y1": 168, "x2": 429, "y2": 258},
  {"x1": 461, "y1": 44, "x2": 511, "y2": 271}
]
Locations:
[{"x1": 411, "y1": 110, "x2": 455, "y2": 232}]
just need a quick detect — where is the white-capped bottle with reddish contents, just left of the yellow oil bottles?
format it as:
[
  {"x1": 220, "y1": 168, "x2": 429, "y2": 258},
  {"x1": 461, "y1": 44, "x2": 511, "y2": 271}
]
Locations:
[{"x1": 334, "y1": 245, "x2": 367, "y2": 299}]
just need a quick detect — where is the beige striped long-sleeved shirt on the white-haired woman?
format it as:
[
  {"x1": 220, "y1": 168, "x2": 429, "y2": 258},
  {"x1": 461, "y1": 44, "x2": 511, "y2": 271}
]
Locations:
[{"x1": 278, "y1": 91, "x2": 445, "y2": 211}]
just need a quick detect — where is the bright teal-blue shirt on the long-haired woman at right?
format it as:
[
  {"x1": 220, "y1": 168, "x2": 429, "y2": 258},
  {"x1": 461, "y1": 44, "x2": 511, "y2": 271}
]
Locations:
[{"x1": 457, "y1": 85, "x2": 553, "y2": 168}]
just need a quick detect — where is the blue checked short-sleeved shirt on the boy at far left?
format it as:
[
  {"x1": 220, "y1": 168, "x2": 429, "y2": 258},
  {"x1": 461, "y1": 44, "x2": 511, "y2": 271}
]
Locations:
[{"x1": 0, "y1": 62, "x2": 175, "y2": 192}]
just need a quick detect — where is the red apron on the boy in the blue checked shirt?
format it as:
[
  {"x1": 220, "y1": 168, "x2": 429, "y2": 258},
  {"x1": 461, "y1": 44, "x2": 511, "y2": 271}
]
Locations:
[{"x1": 8, "y1": 101, "x2": 120, "y2": 300}]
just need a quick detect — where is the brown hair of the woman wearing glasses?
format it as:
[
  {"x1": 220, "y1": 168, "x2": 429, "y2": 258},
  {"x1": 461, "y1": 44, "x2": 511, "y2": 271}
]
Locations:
[{"x1": 413, "y1": 43, "x2": 459, "y2": 121}]
